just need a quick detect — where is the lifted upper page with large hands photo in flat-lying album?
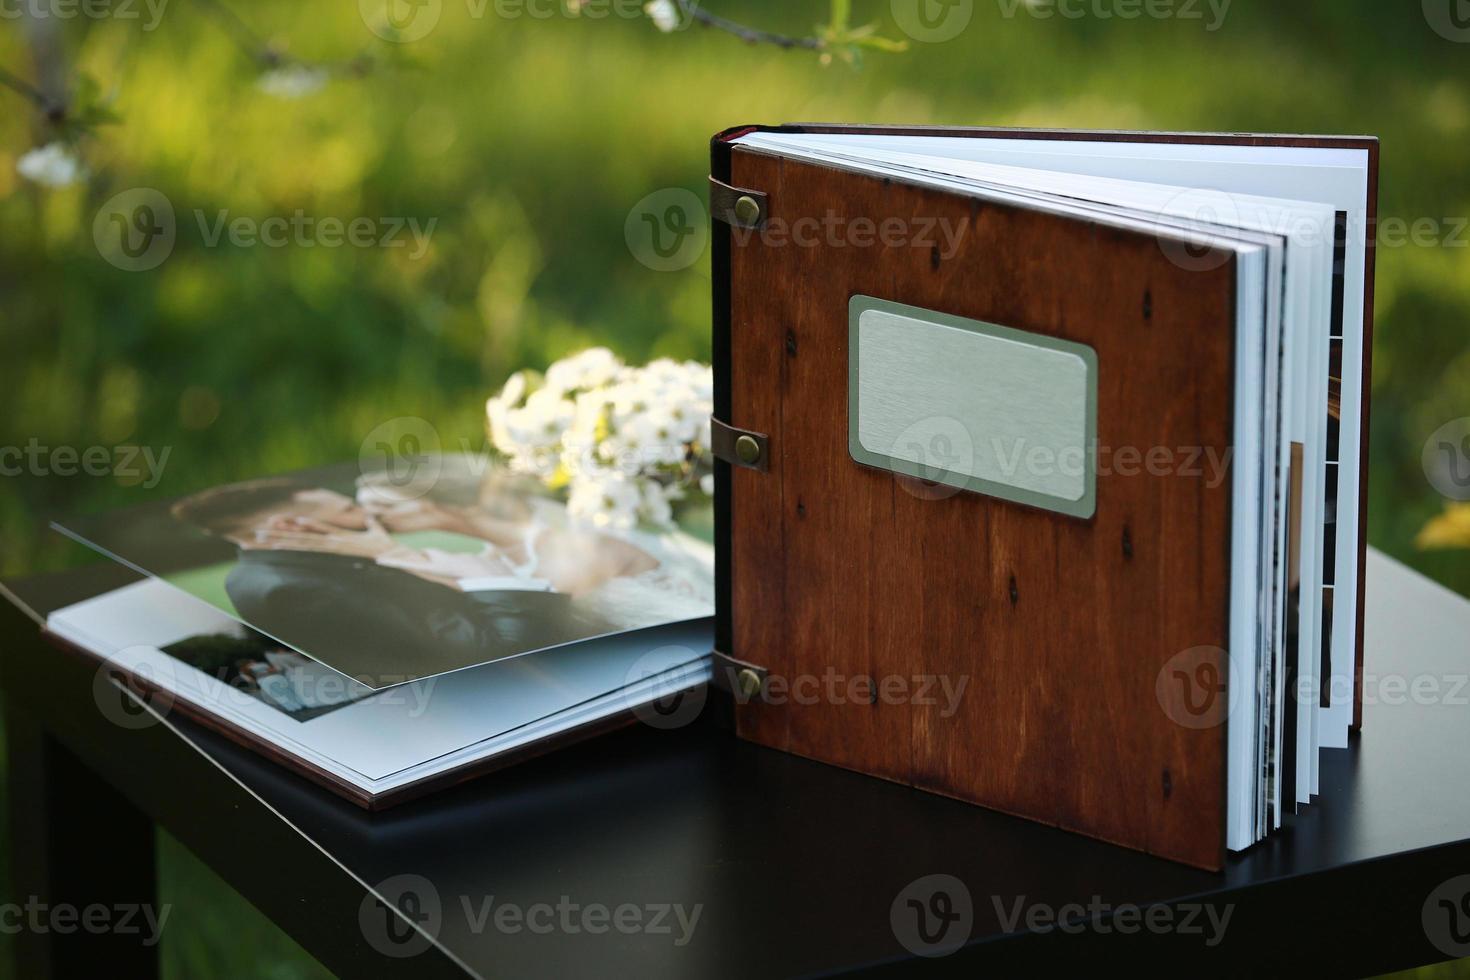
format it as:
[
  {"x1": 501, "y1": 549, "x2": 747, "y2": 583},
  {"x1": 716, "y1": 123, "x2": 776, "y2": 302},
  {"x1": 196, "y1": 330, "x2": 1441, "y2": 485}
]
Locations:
[{"x1": 57, "y1": 455, "x2": 714, "y2": 689}]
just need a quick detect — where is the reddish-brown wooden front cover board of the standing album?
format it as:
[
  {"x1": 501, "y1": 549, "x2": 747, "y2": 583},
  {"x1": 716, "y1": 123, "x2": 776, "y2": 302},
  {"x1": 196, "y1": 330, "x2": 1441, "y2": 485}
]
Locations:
[{"x1": 716, "y1": 147, "x2": 1235, "y2": 868}]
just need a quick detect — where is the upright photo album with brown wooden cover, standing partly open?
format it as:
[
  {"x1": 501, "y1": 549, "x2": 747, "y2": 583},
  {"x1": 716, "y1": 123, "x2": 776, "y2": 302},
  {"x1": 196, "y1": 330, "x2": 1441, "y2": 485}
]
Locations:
[{"x1": 710, "y1": 123, "x2": 1377, "y2": 867}]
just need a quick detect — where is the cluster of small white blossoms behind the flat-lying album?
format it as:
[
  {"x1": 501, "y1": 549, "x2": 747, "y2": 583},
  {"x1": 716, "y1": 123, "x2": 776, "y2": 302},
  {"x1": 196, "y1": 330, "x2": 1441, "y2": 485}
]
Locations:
[{"x1": 485, "y1": 347, "x2": 714, "y2": 529}]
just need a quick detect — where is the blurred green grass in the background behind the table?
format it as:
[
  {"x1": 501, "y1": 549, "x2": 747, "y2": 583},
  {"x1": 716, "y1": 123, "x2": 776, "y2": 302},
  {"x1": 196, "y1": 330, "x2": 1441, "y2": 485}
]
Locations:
[{"x1": 0, "y1": 0, "x2": 1470, "y2": 976}]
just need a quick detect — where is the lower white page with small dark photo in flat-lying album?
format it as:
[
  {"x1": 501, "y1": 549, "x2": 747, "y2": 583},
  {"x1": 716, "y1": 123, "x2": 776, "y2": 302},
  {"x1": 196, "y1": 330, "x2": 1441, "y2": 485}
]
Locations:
[{"x1": 47, "y1": 579, "x2": 710, "y2": 792}]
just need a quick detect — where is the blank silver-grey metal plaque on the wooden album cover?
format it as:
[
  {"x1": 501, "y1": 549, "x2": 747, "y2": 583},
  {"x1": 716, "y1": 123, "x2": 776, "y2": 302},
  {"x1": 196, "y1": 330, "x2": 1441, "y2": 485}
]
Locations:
[{"x1": 847, "y1": 295, "x2": 1097, "y2": 517}]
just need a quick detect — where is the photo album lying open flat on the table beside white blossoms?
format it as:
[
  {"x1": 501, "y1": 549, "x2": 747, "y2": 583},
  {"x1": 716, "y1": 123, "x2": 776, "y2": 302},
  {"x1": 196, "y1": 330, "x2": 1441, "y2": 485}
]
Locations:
[{"x1": 17, "y1": 457, "x2": 713, "y2": 810}]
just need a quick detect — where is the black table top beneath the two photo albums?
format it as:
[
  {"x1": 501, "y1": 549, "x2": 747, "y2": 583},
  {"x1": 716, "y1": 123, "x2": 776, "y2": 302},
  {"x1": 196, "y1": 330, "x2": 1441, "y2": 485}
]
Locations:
[{"x1": 4, "y1": 554, "x2": 1470, "y2": 977}]
